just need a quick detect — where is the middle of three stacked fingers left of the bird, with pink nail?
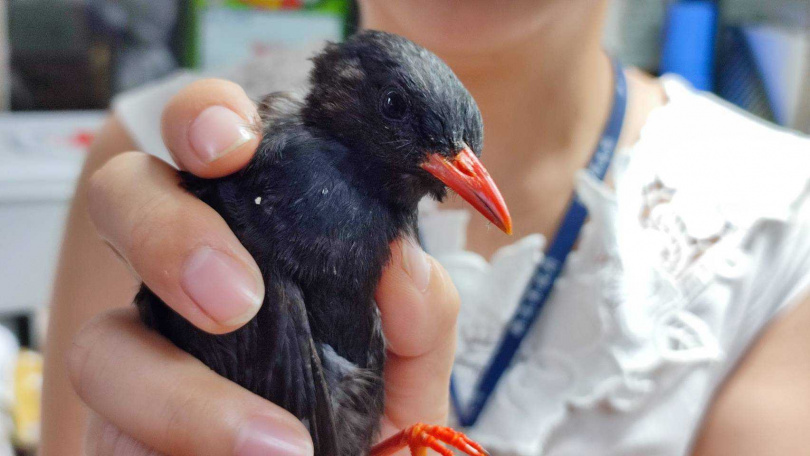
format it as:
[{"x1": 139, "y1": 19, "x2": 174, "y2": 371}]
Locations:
[{"x1": 88, "y1": 152, "x2": 264, "y2": 333}]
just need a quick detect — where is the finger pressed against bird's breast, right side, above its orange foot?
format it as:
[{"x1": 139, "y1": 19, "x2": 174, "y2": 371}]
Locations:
[{"x1": 376, "y1": 241, "x2": 459, "y2": 429}]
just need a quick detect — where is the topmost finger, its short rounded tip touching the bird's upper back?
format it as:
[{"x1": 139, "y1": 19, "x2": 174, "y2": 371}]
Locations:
[{"x1": 161, "y1": 79, "x2": 261, "y2": 178}]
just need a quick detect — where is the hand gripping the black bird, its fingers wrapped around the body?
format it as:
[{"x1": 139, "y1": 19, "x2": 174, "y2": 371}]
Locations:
[{"x1": 69, "y1": 80, "x2": 459, "y2": 455}]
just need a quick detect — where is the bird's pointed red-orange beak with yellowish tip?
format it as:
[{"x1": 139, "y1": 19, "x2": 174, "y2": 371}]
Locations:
[{"x1": 421, "y1": 146, "x2": 512, "y2": 234}]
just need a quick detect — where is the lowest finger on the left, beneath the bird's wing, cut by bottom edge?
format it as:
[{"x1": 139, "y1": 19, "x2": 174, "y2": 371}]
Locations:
[{"x1": 68, "y1": 309, "x2": 313, "y2": 456}]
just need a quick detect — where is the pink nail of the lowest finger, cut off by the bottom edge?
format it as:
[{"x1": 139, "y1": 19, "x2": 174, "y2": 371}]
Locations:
[{"x1": 234, "y1": 417, "x2": 314, "y2": 456}]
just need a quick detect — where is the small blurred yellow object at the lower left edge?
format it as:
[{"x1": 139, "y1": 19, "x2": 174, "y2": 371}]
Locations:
[{"x1": 12, "y1": 350, "x2": 42, "y2": 448}]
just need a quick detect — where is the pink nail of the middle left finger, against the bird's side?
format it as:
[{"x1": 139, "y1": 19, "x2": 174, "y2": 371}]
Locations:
[{"x1": 180, "y1": 247, "x2": 263, "y2": 326}]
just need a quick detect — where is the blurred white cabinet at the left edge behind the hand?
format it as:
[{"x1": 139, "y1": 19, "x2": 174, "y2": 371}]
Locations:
[{"x1": 0, "y1": 112, "x2": 104, "y2": 316}]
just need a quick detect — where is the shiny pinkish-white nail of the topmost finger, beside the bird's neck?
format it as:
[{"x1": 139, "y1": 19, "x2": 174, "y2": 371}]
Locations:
[{"x1": 188, "y1": 106, "x2": 256, "y2": 163}]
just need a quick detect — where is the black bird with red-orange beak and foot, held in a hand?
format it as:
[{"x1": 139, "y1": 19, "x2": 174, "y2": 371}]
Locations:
[{"x1": 135, "y1": 31, "x2": 511, "y2": 456}]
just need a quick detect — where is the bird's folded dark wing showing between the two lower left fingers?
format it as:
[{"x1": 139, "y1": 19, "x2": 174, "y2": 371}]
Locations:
[{"x1": 135, "y1": 274, "x2": 339, "y2": 455}]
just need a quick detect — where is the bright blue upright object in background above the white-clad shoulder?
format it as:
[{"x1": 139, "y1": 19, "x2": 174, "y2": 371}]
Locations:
[{"x1": 661, "y1": 0, "x2": 717, "y2": 90}]
